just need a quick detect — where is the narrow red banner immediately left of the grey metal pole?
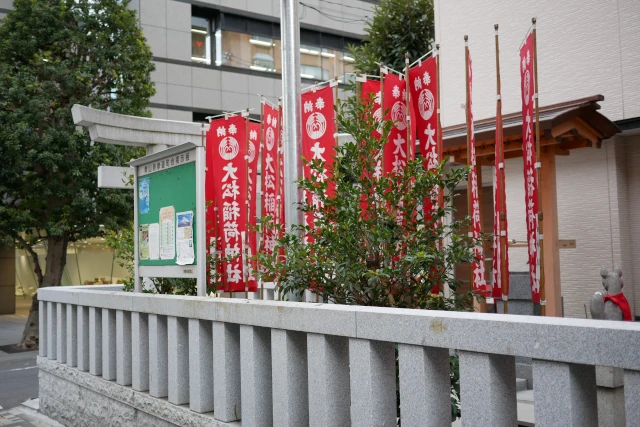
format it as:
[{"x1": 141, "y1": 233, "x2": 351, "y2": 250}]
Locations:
[{"x1": 261, "y1": 102, "x2": 280, "y2": 254}]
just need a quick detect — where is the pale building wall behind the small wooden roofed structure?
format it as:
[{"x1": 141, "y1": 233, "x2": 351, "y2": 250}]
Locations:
[{"x1": 435, "y1": 0, "x2": 640, "y2": 318}]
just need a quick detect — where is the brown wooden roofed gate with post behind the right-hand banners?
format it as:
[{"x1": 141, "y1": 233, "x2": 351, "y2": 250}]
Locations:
[{"x1": 443, "y1": 95, "x2": 620, "y2": 317}]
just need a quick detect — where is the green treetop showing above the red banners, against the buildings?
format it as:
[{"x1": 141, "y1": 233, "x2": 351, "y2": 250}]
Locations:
[{"x1": 349, "y1": 0, "x2": 435, "y2": 74}]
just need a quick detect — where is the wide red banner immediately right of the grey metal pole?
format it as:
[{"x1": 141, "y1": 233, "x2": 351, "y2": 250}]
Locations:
[{"x1": 302, "y1": 86, "x2": 336, "y2": 236}]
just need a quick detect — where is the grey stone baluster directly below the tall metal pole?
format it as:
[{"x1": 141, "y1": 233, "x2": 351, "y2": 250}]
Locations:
[{"x1": 271, "y1": 329, "x2": 309, "y2": 427}]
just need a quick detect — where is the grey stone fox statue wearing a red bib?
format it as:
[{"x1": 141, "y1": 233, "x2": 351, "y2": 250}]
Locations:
[{"x1": 589, "y1": 267, "x2": 633, "y2": 321}]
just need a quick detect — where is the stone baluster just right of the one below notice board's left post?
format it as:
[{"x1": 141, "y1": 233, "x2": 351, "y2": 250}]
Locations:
[{"x1": 149, "y1": 314, "x2": 169, "y2": 397}]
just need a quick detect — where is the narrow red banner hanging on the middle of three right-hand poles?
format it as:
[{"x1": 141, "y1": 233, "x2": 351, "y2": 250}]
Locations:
[{"x1": 493, "y1": 101, "x2": 509, "y2": 298}]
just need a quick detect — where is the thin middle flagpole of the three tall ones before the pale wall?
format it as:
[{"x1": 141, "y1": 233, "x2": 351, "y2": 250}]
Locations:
[{"x1": 494, "y1": 24, "x2": 509, "y2": 314}]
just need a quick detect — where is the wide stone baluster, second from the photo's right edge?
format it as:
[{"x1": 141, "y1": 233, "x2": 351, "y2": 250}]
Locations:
[{"x1": 532, "y1": 359, "x2": 598, "y2": 427}]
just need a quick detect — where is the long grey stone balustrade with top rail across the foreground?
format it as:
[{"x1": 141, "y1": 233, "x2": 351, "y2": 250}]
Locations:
[{"x1": 38, "y1": 286, "x2": 640, "y2": 427}]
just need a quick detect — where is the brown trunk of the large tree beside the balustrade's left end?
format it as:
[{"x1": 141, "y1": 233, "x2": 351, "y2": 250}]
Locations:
[{"x1": 17, "y1": 236, "x2": 69, "y2": 350}]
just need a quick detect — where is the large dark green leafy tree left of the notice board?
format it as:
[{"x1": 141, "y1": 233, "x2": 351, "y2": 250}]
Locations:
[{"x1": 0, "y1": 0, "x2": 154, "y2": 348}]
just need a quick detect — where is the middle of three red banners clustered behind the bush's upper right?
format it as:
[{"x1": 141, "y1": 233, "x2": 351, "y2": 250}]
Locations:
[{"x1": 382, "y1": 73, "x2": 409, "y2": 175}]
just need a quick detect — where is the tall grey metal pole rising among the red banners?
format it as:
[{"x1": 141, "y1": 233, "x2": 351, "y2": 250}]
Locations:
[{"x1": 280, "y1": 0, "x2": 302, "y2": 231}]
